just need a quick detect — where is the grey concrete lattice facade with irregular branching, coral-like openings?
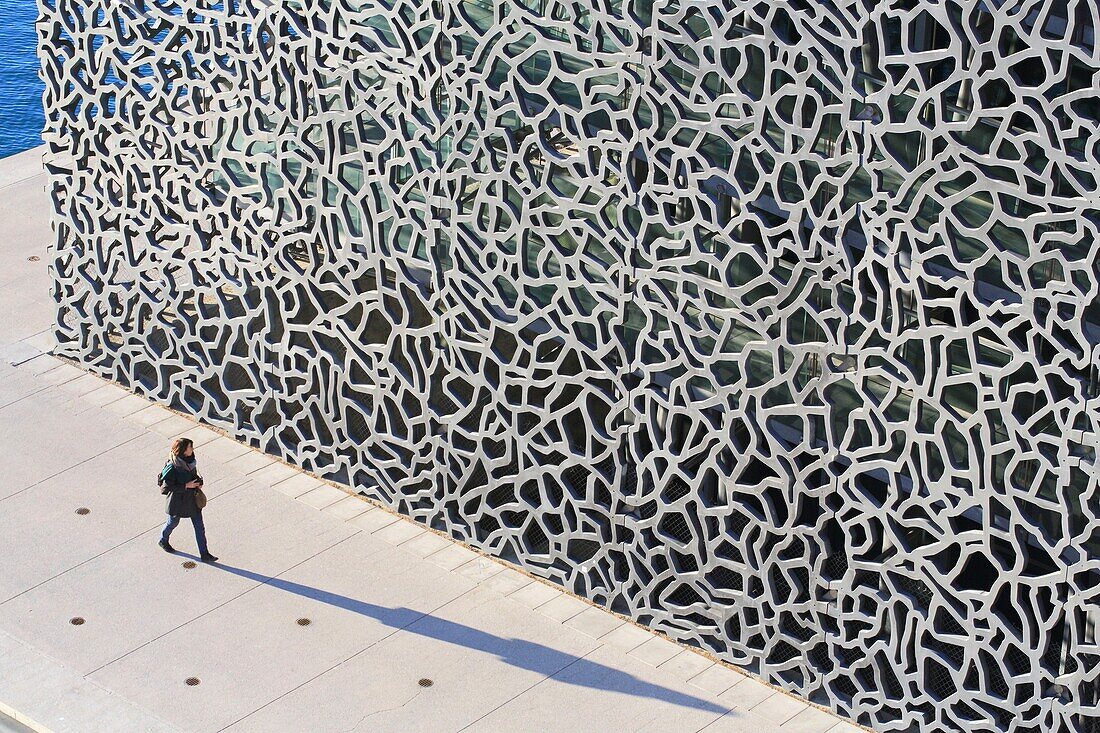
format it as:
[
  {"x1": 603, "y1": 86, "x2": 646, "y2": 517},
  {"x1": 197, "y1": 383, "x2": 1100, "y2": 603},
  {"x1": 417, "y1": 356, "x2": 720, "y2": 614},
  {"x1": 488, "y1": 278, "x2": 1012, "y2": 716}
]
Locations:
[{"x1": 39, "y1": 0, "x2": 1100, "y2": 732}]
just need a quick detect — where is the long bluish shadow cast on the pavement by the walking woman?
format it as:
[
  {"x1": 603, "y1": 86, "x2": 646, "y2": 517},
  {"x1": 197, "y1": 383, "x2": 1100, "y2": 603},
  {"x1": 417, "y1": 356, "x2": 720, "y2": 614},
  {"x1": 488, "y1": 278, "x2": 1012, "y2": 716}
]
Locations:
[{"x1": 207, "y1": 562, "x2": 730, "y2": 715}]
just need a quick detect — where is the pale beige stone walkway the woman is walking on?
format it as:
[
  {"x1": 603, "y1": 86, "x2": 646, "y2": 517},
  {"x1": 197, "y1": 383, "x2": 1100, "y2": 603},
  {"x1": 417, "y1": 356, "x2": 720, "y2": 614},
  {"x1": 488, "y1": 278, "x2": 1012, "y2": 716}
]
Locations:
[{"x1": 0, "y1": 151, "x2": 861, "y2": 733}]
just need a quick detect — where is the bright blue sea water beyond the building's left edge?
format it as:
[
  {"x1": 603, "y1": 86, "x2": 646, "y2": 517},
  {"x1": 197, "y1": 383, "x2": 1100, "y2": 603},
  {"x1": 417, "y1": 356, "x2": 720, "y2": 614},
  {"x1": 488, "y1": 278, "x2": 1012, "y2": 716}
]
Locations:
[{"x1": 0, "y1": 0, "x2": 45, "y2": 157}]
